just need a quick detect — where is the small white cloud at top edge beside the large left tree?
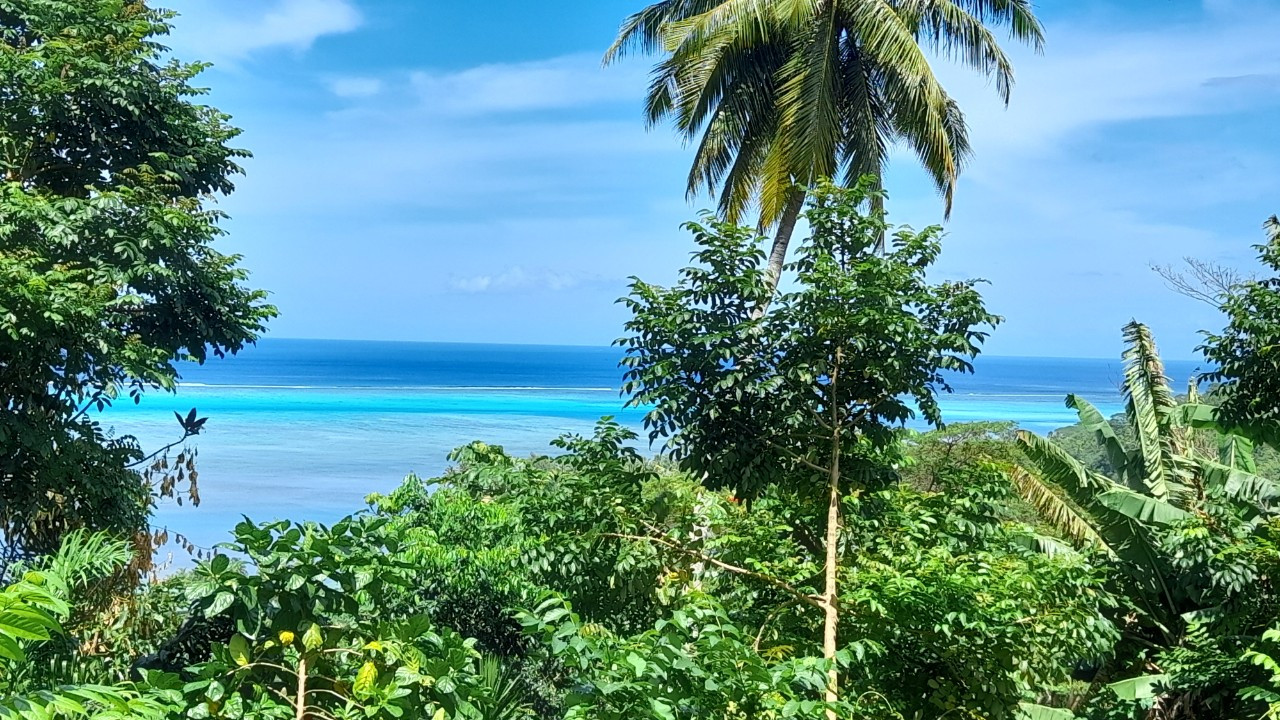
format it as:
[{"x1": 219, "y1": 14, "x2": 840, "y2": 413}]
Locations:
[{"x1": 173, "y1": 0, "x2": 362, "y2": 63}]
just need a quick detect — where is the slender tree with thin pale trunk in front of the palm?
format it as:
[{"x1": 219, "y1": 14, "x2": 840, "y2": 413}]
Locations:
[{"x1": 620, "y1": 178, "x2": 998, "y2": 715}]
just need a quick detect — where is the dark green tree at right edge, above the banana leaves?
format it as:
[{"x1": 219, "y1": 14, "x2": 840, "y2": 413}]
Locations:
[{"x1": 1201, "y1": 210, "x2": 1280, "y2": 446}]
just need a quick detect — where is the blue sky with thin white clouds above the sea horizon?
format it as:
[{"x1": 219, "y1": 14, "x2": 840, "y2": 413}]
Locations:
[{"x1": 169, "y1": 0, "x2": 1280, "y2": 357}]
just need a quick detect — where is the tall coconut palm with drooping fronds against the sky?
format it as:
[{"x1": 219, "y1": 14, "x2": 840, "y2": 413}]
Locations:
[{"x1": 604, "y1": 0, "x2": 1043, "y2": 284}]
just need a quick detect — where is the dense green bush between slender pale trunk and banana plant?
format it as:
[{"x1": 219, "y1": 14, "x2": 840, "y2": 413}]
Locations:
[{"x1": 847, "y1": 464, "x2": 1117, "y2": 717}]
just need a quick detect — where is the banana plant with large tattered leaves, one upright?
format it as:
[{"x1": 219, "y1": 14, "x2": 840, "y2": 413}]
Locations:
[{"x1": 1011, "y1": 322, "x2": 1280, "y2": 642}]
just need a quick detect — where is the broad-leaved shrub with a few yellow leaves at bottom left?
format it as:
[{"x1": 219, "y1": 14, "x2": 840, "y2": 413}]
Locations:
[{"x1": 137, "y1": 516, "x2": 524, "y2": 720}]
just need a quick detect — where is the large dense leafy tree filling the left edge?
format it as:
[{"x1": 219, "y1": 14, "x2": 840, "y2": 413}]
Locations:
[{"x1": 0, "y1": 0, "x2": 275, "y2": 566}]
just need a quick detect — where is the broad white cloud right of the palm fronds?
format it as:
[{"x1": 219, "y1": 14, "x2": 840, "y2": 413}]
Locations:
[{"x1": 940, "y1": 9, "x2": 1280, "y2": 159}]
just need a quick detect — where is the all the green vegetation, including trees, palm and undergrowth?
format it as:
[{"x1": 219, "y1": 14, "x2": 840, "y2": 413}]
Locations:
[{"x1": 0, "y1": 0, "x2": 1280, "y2": 720}]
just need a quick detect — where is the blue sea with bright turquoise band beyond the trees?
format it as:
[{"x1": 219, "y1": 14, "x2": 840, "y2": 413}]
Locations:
[{"x1": 101, "y1": 340, "x2": 1196, "y2": 546}]
